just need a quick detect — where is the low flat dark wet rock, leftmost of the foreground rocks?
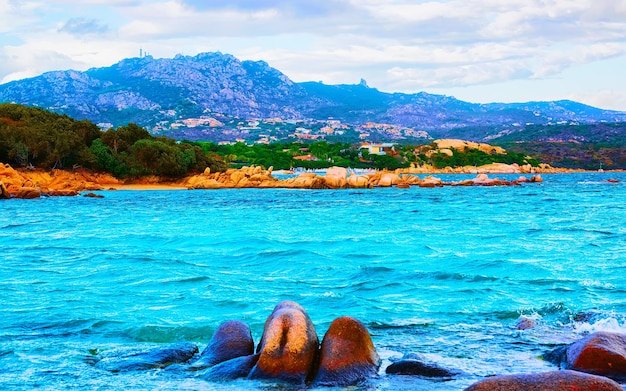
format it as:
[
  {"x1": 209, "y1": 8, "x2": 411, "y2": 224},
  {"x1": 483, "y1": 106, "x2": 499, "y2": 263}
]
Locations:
[{"x1": 95, "y1": 342, "x2": 198, "y2": 372}]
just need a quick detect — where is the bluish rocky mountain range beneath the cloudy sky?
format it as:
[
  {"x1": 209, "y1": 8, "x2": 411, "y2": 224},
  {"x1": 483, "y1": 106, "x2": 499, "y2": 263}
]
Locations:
[{"x1": 0, "y1": 52, "x2": 626, "y2": 141}]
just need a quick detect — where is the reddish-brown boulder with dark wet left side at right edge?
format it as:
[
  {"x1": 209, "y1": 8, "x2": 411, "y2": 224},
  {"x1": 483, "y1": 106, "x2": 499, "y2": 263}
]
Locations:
[{"x1": 544, "y1": 331, "x2": 626, "y2": 380}]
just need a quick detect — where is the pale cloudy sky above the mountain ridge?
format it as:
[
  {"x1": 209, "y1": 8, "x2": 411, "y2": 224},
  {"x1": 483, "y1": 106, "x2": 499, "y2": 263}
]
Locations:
[{"x1": 0, "y1": 0, "x2": 626, "y2": 111}]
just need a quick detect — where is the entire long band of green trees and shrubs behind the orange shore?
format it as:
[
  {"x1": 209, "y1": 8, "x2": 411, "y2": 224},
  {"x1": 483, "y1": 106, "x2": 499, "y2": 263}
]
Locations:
[{"x1": 0, "y1": 104, "x2": 539, "y2": 178}]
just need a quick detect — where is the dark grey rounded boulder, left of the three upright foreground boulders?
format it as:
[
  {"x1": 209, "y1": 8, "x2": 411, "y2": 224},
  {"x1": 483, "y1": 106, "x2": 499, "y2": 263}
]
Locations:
[{"x1": 192, "y1": 320, "x2": 254, "y2": 375}]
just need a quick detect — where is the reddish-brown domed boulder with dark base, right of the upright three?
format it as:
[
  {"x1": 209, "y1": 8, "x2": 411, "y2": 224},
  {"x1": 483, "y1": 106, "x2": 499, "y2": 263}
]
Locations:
[{"x1": 313, "y1": 316, "x2": 380, "y2": 387}]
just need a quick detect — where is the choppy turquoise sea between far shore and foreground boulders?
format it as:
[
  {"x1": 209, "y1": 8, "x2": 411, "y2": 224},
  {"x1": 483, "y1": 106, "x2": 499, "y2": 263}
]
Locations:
[{"x1": 0, "y1": 173, "x2": 626, "y2": 390}]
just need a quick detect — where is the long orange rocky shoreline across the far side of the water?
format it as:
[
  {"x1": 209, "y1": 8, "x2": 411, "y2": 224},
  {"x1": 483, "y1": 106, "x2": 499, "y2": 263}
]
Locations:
[{"x1": 0, "y1": 163, "x2": 556, "y2": 199}]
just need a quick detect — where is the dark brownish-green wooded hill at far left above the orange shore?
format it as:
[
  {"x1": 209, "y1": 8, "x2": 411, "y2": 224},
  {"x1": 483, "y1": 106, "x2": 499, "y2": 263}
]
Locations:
[{"x1": 0, "y1": 104, "x2": 227, "y2": 178}]
